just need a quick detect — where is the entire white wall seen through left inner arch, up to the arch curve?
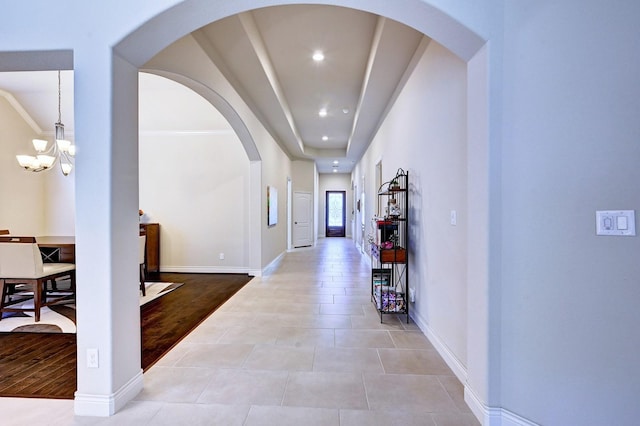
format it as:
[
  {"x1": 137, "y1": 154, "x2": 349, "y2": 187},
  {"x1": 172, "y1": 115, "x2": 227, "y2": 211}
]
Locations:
[{"x1": 139, "y1": 73, "x2": 250, "y2": 273}]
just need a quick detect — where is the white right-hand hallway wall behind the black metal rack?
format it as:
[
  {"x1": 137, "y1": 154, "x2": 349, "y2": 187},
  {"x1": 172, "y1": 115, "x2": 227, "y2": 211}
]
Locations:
[{"x1": 357, "y1": 41, "x2": 468, "y2": 374}]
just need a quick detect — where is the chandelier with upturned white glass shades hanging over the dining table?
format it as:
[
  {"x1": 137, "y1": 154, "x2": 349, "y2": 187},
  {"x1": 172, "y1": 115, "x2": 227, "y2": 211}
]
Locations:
[{"x1": 16, "y1": 71, "x2": 76, "y2": 176}]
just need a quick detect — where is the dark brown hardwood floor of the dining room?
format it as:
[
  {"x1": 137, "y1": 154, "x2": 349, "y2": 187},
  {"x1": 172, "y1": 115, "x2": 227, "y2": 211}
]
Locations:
[{"x1": 0, "y1": 273, "x2": 251, "y2": 399}]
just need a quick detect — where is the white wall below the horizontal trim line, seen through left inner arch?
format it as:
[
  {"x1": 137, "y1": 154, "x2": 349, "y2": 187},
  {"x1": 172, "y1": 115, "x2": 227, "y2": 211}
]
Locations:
[{"x1": 139, "y1": 131, "x2": 249, "y2": 273}]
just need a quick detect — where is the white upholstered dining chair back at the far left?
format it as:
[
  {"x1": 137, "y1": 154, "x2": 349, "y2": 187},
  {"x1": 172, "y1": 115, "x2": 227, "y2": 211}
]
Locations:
[{"x1": 0, "y1": 240, "x2": 44, "y2": 278}]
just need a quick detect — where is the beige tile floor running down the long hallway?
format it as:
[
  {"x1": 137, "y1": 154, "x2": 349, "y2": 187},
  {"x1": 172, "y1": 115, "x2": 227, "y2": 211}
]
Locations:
[{"x1": 0, "y1": 238, "x2": 479, "y2": 426}]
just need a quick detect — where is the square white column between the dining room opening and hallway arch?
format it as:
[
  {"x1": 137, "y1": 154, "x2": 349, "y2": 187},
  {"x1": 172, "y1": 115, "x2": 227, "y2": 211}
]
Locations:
[{"x1": 74, "y1": 49, "x2": 142, "y2": 416}]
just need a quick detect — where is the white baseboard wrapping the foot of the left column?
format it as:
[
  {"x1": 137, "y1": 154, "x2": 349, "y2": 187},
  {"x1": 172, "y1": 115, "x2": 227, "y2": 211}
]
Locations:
[{"x1": 73, "y1": 369, "x2": 143, "y2": 417}]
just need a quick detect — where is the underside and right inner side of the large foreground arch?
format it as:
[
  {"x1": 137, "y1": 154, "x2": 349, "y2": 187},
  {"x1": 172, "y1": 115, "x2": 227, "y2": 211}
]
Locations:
[{"x1": 114, "y1": 0, "x2": 492, "y2": 417}]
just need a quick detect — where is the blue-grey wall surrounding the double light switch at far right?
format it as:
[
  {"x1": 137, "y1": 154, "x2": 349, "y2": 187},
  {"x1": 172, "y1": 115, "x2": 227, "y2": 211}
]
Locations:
[{"x1": 500, "y1": 0, "x2": 640, "y2": 425}]
